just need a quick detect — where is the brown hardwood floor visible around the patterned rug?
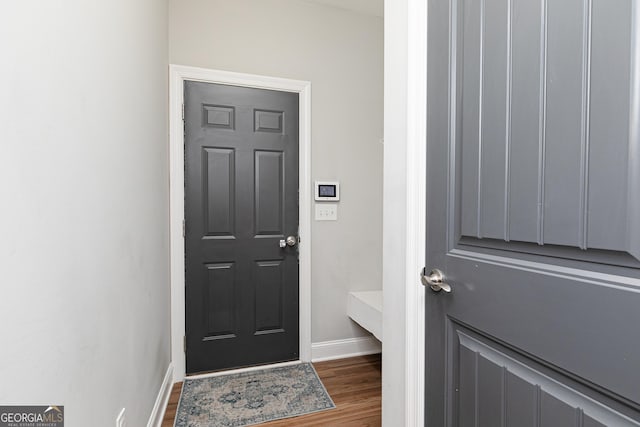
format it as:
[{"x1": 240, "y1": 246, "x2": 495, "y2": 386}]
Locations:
[{"x1": 162, "y1": 354, "x2": 382, "y2": 427}]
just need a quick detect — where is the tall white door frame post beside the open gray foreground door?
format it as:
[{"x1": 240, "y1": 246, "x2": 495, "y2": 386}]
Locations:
[{"x1": 382, "y1": 0, "x2": 428, "y2": 427}]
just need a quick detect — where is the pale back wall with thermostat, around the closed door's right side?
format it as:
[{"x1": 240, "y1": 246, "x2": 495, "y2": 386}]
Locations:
[{"x1": 169, "y1": 0, "x2": 383, "y2": 342}]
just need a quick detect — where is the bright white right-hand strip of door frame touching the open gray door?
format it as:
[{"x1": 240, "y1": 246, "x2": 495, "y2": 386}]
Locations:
[{"x1": 405, "y1": 0, "x2": 427, "y2": 427}]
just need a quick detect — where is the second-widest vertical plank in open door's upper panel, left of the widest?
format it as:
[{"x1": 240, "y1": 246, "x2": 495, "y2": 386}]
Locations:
[{"x1": 540, "y1": 0, "x2": 587, "y2": 247}]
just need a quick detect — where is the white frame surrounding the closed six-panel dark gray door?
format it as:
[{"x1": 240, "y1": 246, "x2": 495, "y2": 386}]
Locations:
[{"x1": 169, "y1": 64, "x2": 311, "y2": 382}]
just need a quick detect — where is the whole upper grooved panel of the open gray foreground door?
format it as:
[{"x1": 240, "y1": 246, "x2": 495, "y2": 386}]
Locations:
[{"x1": 451, "y1": 0, "x2": 640, "y2": 267}]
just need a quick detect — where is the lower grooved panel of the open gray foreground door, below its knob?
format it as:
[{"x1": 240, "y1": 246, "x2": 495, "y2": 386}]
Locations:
[{"x1": 450, "y1": 330, "x2": 640, "y2": 427}]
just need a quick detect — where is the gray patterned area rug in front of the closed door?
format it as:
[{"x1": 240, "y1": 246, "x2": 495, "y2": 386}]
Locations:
[{"x1": 174, "y1": 363, "x2": 335, "y2": 427}]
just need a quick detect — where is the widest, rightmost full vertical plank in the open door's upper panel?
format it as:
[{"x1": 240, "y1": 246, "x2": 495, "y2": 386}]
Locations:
[{"x1": 586, "y1": 0, "x2": 640, "y2": 251}]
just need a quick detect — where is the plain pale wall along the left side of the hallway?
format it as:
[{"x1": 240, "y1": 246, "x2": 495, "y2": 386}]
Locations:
[{"x1": 0, "y1": 0, "x2": 170, "y2": 427}]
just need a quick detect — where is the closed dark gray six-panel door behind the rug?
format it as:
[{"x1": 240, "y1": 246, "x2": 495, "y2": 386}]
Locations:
[{"x1": 185, "y1": 82, "x2": 299, "y2": 373}]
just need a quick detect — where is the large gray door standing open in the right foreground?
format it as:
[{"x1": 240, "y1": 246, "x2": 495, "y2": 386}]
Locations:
[{"x1": 425, "y1": 0, "x2": 640, "y2": 427}]
